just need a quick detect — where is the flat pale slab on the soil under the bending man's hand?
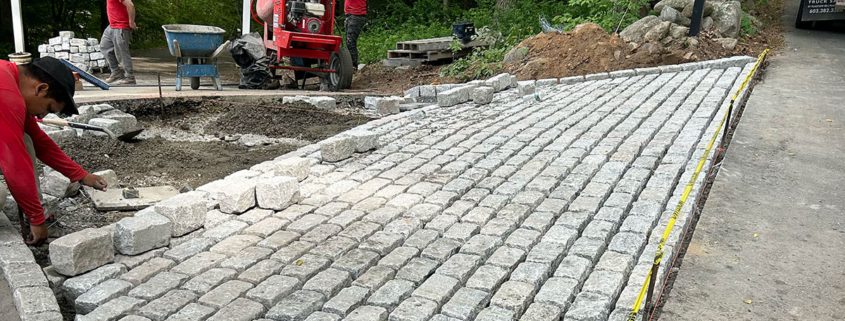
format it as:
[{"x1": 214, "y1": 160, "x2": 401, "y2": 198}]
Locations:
[{"x1": 84, "y1": 186, "x2": 179, "y2": 211}]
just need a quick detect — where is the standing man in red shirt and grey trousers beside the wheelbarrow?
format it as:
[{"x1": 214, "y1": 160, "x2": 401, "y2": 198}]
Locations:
[{"x1": 100, "y1": 0, "x2": 138, "y2": 85}]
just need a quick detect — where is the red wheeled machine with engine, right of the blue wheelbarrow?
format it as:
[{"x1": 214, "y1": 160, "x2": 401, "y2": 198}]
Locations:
[{"x1": 250, "y1": 0, "x2": 353, "y2": 91}]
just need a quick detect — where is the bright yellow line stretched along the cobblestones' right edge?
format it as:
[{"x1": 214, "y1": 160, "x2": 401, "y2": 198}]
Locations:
[{"x1": 628, "y1": 49, "x2": 769, "y2": 321}]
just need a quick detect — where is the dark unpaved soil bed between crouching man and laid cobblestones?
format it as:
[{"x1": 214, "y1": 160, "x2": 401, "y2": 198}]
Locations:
[{"x1": 23, "y1": 97, "x2": 370, "y2": 266}]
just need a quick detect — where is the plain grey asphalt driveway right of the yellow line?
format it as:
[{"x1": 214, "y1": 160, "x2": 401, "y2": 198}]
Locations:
[{"x1": 661, "y1": 1, "x2": 845, "y2": 320}]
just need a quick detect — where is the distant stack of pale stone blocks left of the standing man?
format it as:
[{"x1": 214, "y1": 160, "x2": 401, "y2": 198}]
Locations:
[{"x1": 38, "y1": 31, "x2": 108, "y2": 72}]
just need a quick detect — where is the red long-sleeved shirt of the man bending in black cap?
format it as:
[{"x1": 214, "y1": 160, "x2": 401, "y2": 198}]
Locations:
[{"x1": 0, "y1": 60, "x2": 88, "y2": 225}]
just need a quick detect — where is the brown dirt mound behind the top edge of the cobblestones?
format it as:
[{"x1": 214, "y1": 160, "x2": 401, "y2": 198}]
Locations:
[{"x1": 507, "y1": 23, "x2": 681, "y2": 80}]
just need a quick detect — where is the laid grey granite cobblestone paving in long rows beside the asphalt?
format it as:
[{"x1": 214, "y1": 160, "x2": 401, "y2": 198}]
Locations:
[{"x1": 65, "y1": 60, "x2": 750, "y2": 321}]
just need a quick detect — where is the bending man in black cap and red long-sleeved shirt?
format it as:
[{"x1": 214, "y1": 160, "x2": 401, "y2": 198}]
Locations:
[{"x1": 0, "y1": 57, "x2": 108, "y2": 245}]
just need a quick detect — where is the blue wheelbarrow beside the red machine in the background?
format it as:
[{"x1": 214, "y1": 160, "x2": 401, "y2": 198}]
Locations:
[{"x1": 161, "y1": 24, "x2": 229, "y2": 91}]
